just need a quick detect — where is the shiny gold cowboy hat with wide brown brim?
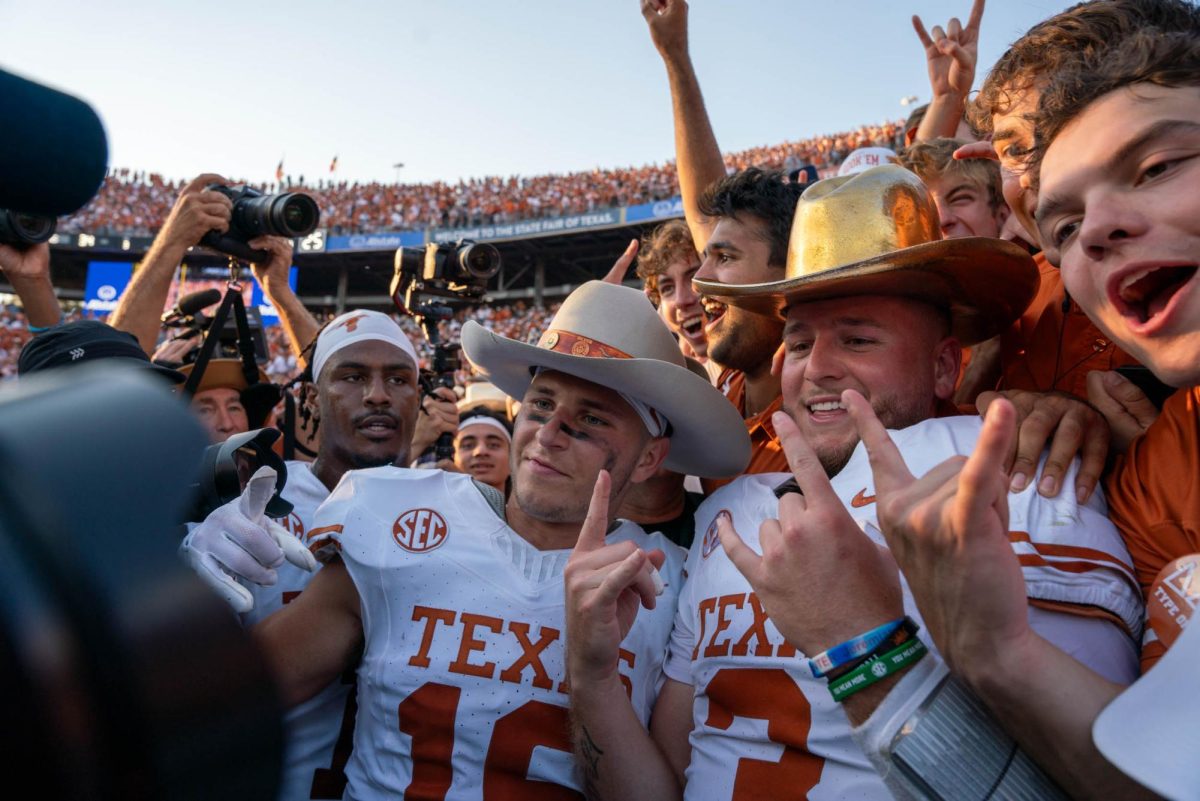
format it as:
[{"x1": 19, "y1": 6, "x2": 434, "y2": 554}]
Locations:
[{"x1": 694, "y1": 164, "x2": 1039, "y2": 345}]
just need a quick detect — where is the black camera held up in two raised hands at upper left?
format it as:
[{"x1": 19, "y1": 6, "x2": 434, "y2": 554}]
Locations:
[{"x1": 200, "y1": 183, "x2": 320, "y2": 263}]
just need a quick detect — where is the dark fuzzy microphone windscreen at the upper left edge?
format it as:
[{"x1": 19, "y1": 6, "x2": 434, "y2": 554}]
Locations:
[{"x1": 0, "y1": 70, "x2": 108, "y2": 217}]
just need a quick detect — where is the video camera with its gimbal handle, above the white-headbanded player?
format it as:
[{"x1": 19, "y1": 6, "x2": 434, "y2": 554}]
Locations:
[{"x1": 390, "y1": 240, "x2": 500, "y2": 462}]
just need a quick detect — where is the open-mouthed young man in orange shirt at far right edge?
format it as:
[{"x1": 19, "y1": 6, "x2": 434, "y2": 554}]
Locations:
[{"x1": 1036, "y1": 17, "x2": 1200, "y2": 797}]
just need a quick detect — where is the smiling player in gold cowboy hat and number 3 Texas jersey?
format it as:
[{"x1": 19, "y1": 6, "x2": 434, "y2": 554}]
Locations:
[{"x1": 569, "y1": 165, "x2": 1141, "y2": 800}]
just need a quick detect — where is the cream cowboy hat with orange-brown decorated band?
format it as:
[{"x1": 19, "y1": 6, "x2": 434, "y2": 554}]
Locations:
[{"x1": 462, "y1": 281, "x2": 750, "y2": 478}]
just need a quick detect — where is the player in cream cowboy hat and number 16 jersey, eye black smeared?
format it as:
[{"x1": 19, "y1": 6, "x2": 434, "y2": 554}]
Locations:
[{"x1": 237, "y1": 282, "x2": 749, "y2": 799}]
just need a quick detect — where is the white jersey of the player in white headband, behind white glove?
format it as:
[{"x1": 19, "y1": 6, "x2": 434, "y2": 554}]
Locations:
[{"x1": 241, "y1": 462, "x2": 355, "y2": 801}]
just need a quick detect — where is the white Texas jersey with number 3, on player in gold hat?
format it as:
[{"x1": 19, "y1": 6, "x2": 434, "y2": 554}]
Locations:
[{"x1": 665, "y1": 417, "x2": 1141, "y2": 801}]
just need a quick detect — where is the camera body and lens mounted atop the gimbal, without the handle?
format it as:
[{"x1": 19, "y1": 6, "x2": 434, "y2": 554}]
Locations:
[{"x1": 391, "y1": 240, "x2": 500, "y2": 300}]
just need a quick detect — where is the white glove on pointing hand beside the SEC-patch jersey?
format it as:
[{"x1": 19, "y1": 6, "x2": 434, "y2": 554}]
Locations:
[{"x1": 180, "y1": 466, "x2": 317, "y2": 614}]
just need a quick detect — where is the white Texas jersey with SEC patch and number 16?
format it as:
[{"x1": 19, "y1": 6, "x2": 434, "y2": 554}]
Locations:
[{"x1": 308, "y1": 468, "x2": 684, "y2": 801}]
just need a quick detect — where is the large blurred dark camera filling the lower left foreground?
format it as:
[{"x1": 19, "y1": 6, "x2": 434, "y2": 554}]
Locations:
[{"x1": 0, "y1": 360, "x2": 283, "y2": 801}]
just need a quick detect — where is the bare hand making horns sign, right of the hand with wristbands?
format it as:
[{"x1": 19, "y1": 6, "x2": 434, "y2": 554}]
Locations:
[{"x1": 841, "y1": 390, "x2": 1030, "y2": 668}]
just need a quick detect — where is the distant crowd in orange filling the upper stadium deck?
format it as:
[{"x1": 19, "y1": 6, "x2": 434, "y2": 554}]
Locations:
[{"x1": 59, "y1": 122, "x2": 904, "y2": 236}]
